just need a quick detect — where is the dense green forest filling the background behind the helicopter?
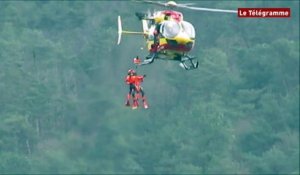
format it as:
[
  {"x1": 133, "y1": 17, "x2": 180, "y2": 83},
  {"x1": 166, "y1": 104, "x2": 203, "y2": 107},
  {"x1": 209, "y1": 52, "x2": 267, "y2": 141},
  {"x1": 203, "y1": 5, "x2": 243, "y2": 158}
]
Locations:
[{"x1": 0, "y1": 0, "x2": 300, "y2": 174}]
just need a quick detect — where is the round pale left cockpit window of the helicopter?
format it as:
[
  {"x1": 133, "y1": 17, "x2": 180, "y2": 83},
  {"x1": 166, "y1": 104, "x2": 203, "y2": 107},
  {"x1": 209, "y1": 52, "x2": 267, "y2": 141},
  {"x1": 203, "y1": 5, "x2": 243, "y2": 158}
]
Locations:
[{"x1": 160, "y1": 21, "x2": 180, "y2": 38}]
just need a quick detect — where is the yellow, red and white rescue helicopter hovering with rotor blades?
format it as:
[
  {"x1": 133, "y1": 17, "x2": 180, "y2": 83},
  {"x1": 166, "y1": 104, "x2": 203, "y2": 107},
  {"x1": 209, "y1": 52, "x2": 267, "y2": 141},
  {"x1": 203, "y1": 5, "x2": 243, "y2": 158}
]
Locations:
[{"x1": 117, "y1": 1, "x2": 237, "y2": 70}]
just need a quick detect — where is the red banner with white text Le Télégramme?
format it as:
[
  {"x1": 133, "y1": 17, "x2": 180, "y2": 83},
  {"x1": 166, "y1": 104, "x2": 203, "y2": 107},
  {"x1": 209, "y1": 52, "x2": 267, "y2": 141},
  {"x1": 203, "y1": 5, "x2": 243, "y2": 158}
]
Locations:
[{"x1": 238, "y1": 8, "x2": 291, "y2": 18}]
